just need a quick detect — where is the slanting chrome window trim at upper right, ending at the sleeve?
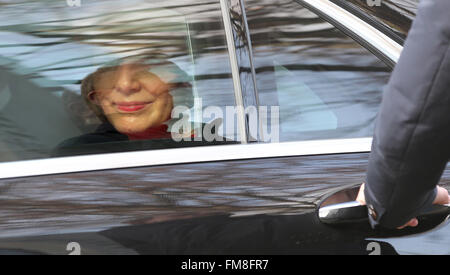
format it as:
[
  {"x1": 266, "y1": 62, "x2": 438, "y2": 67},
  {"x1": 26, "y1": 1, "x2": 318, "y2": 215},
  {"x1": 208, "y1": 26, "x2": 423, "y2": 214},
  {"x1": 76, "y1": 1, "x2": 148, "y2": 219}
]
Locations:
[{"x1": 296, "y1": 0, "x2": 403, "y2": 64}]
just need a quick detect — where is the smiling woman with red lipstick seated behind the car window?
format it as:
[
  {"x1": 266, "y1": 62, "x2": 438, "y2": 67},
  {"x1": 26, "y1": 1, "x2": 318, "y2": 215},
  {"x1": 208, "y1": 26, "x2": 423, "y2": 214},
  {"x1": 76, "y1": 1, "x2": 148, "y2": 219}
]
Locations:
[{"x1": 53, "y1": 58, "x2": 239, "y2": 156}]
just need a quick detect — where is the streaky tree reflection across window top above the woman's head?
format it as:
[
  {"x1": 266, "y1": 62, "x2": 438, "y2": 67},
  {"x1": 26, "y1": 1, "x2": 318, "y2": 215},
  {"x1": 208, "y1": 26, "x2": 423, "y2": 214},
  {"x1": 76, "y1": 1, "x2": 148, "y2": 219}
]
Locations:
[{"x1": 0, "y1": 0, "x2": 229, "y2": 80}]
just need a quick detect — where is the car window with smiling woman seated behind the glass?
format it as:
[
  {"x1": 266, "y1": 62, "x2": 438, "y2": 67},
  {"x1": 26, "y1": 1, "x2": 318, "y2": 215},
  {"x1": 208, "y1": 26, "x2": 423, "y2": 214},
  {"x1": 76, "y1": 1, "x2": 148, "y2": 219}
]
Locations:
[{"x1": 0, "y1": 0, "x2": 239, "y2": 162}]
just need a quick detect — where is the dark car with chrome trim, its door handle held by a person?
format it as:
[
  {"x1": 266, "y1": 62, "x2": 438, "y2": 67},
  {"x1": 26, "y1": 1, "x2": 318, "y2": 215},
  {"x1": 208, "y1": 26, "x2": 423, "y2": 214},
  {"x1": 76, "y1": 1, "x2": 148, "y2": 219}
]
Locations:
[{"x1": 0, "y1": 0, "x2": 450, "y2": 255}]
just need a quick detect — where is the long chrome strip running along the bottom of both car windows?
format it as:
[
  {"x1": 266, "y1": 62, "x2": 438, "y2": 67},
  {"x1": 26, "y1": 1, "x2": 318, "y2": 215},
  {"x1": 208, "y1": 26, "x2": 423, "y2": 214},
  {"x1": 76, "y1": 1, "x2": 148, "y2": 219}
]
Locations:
[{"x1": 0, "y1": 138, "x2": 372, "y2": 179}]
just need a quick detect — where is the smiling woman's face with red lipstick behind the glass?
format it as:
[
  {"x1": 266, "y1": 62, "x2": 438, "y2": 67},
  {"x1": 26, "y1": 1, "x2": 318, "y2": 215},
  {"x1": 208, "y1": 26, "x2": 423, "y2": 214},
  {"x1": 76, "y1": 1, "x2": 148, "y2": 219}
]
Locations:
[{"x1": 89, "y1": 64, "x2": 173, "y2": 134}]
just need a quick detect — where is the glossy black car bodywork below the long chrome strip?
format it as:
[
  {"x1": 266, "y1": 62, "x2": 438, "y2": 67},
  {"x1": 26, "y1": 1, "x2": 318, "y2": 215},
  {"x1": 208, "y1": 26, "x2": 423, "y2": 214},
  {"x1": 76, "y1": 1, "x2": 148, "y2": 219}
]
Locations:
[{"x1": 0, "y1": 153, "x2": 450, "y2": 254}]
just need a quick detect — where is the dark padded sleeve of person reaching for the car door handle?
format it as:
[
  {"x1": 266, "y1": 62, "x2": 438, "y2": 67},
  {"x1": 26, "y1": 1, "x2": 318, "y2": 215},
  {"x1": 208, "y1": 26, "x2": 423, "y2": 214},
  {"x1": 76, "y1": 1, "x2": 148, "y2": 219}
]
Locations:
[{"x1": 365, "y1": 0, "x2": 450, "y2": 228}]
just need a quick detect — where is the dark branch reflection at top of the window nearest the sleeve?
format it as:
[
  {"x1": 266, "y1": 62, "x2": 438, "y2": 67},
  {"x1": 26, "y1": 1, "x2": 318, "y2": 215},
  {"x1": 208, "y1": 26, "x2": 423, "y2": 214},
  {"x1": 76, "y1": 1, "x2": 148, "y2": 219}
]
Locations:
[{"x1": 246, "y1": 0, "x2": 380, "y2": 62}]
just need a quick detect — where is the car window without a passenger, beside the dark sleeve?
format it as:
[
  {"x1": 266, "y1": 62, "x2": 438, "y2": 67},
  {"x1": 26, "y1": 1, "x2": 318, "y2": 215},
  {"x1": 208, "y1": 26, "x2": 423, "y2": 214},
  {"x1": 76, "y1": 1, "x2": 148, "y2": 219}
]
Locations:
[{"x1": 246, "y1": 0, "x2": 391, "y2": 142}]
